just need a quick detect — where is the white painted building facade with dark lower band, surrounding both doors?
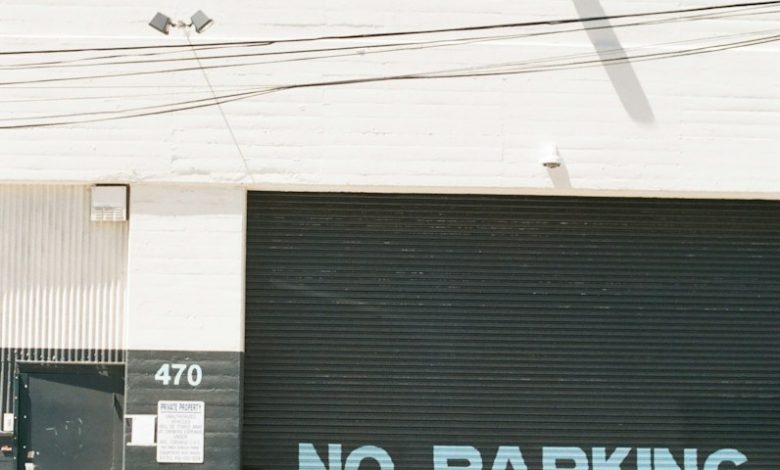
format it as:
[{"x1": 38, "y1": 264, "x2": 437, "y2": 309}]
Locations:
[{"x1": 0, "y1": 0, "x2": 780, "y2": 470}]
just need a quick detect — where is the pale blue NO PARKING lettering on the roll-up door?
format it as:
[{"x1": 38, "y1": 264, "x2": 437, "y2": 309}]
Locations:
[{"x1": 298, "y1": 443, "x2": 748, "y2": 470}]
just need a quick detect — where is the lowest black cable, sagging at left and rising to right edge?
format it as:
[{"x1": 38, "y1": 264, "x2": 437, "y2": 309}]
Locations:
[{"x1": 0, "y1": 30, "x2": 780, "y2": 130}]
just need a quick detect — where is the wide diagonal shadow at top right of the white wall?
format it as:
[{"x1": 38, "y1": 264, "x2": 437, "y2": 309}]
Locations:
[{"x1": 573, "y1": 0, "x2": 655, "y2": 124}]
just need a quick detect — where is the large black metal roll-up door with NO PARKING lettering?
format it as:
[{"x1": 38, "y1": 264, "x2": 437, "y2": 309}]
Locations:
[{"x1": 242, "y1": 192, "x2": 780, "y2": 470}]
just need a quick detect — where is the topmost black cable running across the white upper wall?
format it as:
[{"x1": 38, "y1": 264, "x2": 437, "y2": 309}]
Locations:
[{"x1": 0, "y1": 0, "x2": 780, "y2": 56}]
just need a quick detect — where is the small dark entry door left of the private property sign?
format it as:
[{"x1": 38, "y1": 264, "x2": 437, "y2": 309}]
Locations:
[{"x1": 18, "y1": 366, "x2": 124, "y2": 470}]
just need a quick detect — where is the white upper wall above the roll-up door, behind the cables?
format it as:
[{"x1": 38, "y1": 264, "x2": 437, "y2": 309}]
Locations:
[{"x1": 0, "y1": 0, "x2": 780, "y2": 198}]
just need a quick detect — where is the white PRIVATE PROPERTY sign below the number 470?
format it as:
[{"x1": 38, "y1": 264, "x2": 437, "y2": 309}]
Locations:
[{"x1": 157, "y1": 401, "x2": 206, "y2": 463}]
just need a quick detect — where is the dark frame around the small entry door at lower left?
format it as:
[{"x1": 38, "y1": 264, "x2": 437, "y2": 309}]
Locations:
[{"x1": 13, "y1": 360, "x2": 127, "y2": 470}]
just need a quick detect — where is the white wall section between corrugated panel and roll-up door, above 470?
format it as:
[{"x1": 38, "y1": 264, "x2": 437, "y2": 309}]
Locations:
[{"x1": 127, "y1": 185, "x2": 246, "y2": 351}]
